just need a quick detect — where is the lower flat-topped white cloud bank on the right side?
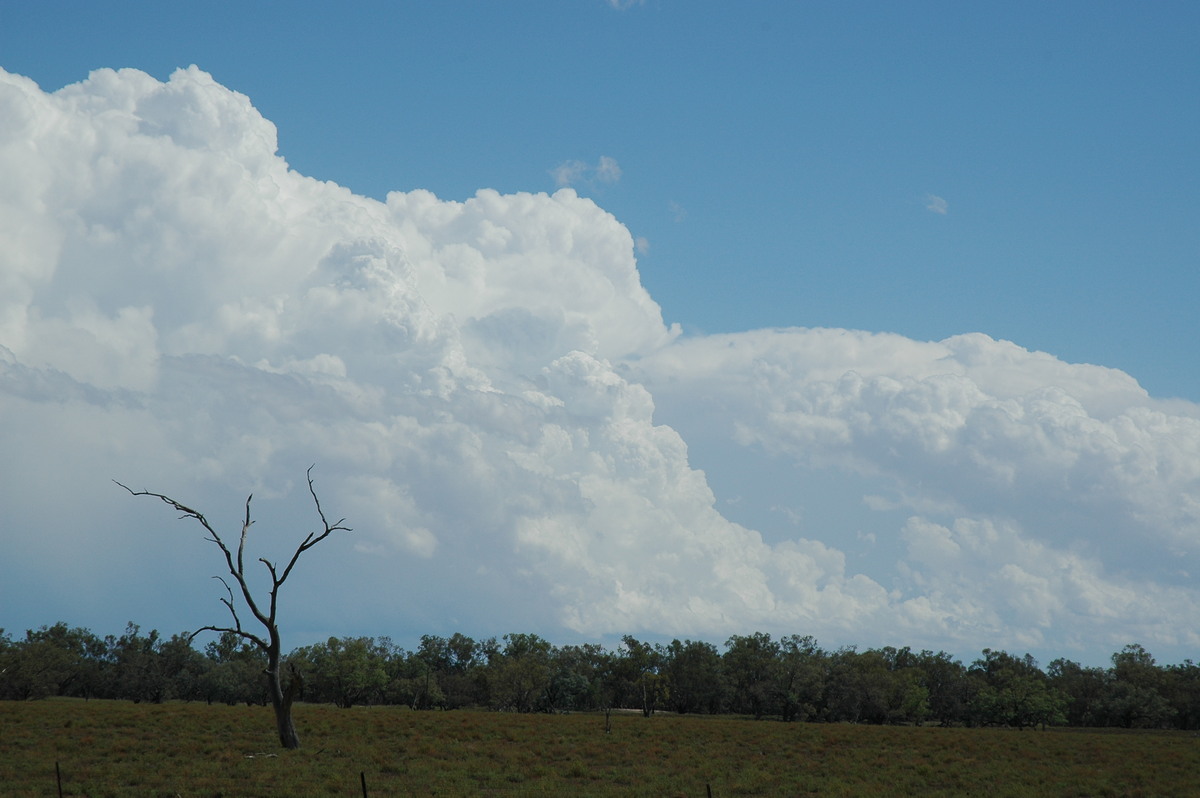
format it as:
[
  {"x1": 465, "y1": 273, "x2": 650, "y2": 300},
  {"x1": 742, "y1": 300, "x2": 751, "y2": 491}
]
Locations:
[{"x1": 630, "y1": 329, "x2": 1200, "y2": 648}]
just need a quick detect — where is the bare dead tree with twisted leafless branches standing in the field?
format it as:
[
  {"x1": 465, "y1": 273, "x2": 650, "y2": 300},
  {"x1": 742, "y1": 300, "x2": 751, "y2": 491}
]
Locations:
[{"x1": 113, "y1": 466, "x2": 350, "y2": 748}]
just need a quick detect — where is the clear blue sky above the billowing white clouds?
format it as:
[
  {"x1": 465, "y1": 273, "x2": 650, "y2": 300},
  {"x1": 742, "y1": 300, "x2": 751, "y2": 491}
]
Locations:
[{"x1": 0, "y1": 0, "x2": 1200, "y2": 400}]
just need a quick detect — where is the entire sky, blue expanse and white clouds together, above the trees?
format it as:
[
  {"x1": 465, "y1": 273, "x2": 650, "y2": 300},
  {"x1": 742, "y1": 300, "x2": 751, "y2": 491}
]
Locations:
[{"x1": 0, "y1": 0, "x2": 1200, "y2": 664}]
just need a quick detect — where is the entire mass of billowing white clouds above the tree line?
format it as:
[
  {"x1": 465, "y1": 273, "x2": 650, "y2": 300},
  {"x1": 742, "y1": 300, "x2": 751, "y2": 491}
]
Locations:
[{"x1": 0, "y1": 67, "x2": 1200, "y2": 653}]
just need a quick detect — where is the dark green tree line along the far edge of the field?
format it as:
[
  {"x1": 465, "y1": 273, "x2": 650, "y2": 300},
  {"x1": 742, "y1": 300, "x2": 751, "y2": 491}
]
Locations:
[{"x1": 0, "y1": 623, "x2": 1200, "y2": 730}]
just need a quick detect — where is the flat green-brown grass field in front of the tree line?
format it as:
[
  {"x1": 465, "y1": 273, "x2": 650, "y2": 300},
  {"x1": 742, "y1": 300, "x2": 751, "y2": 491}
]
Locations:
[{"x1": 0, "y1": 700, "x2": 1200, "y2": 798}]
